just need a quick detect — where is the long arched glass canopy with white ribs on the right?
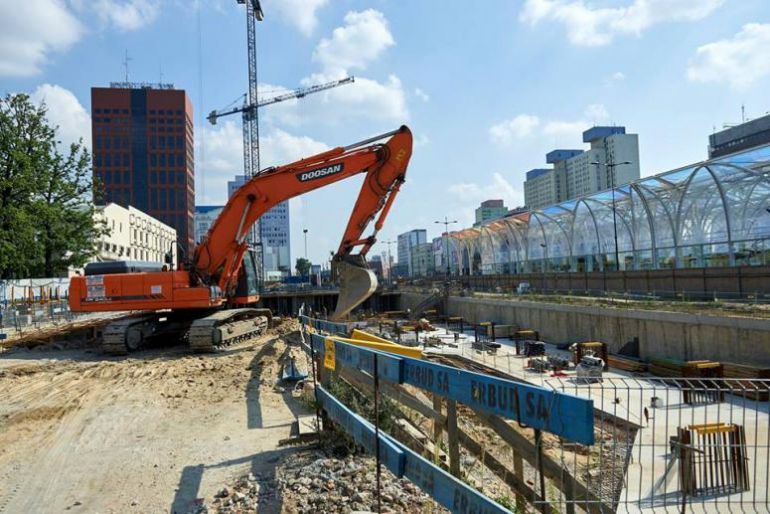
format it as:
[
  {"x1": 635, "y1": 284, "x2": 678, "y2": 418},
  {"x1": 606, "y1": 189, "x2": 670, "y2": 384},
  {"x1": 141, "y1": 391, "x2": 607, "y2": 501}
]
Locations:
[{"x1": 440, "y1": 145, "x2": 770, "y2": 275}]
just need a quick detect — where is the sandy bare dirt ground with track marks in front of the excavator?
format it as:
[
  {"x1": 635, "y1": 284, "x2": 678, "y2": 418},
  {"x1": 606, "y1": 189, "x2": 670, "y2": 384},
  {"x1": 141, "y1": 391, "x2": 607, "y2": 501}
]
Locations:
[{"x1": 0, "y1": 326, "x2": 307, "y2": 513}]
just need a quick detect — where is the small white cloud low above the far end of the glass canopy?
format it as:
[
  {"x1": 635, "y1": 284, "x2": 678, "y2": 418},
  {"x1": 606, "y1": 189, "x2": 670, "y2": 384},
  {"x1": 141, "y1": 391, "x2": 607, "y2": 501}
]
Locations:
[{"x1": 447, "y1": 172, "x2": 524, "y2": 227}]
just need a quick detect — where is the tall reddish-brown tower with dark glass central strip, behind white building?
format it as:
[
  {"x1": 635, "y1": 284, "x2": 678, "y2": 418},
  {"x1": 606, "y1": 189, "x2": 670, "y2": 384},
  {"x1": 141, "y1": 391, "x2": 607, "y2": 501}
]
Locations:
[{"x1": 91, "y1": 82, "x2": 195, "y2": 258}]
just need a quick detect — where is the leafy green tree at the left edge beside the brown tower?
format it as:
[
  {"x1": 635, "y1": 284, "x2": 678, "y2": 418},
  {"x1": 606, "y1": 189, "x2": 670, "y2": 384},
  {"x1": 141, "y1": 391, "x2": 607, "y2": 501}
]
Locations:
[{"x1": 0, "y1": 94, "x2": 106, "y2": 278}]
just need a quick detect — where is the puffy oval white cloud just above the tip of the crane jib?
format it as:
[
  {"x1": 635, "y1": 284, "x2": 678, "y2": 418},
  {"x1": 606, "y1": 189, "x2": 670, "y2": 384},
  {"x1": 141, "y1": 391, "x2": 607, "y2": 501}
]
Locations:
[{"x1": 313, "y1": 9, "x2": 396, "y2": 76}]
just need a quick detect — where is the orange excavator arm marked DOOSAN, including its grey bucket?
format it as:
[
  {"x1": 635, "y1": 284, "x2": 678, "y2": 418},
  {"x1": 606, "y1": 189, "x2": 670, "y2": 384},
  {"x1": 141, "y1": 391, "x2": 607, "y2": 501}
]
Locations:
[{"x1": 191, "y1": 126, "x2": 412, "y2": 317}]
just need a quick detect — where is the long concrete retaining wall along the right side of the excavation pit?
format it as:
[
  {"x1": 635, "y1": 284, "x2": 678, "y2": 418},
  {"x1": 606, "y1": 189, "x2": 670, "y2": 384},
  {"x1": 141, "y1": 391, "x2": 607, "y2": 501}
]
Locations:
[{"x1": 401, "y1": 292, "x2": 770, "y2": 366}]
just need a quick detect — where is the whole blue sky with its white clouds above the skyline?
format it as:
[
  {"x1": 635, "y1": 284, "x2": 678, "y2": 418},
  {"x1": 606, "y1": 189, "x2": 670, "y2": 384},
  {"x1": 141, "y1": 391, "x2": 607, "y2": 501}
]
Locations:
[{"x1": 0, "y1": 0, "x2": 770, "y2": 261}]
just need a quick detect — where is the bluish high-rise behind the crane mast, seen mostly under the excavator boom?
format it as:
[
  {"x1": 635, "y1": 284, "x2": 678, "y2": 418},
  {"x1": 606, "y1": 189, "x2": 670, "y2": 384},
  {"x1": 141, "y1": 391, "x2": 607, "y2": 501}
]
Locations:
[{"x1": 227, "y1": 175, "x2": 292, "y2": 273}]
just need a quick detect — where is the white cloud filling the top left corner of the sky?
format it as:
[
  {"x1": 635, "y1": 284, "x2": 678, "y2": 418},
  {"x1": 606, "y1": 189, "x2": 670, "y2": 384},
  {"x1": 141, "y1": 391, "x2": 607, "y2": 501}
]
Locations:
[{"x1": 0, "y1": 0, "x2": 83, "y2": 77}]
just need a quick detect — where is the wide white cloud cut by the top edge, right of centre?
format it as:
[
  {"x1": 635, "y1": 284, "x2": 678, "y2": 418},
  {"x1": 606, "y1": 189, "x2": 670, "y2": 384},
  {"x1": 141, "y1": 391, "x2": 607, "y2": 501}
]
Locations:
[{"x1": 519, "y1": 0, "x2": 725, "y2": 46}]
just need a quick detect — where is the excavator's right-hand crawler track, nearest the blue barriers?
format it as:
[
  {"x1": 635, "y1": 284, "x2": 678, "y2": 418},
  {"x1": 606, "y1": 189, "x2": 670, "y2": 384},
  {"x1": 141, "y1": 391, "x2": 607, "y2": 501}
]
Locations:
[{"x1": 187, "y1": 308, "x2": 272, "y2": 353}]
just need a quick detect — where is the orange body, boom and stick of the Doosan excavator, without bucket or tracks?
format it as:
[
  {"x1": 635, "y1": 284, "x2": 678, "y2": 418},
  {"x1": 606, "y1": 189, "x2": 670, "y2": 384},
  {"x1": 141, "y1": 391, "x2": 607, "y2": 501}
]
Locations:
[{"x1": 70, "y1": 127, "x2": 412, "y2": 312}]
